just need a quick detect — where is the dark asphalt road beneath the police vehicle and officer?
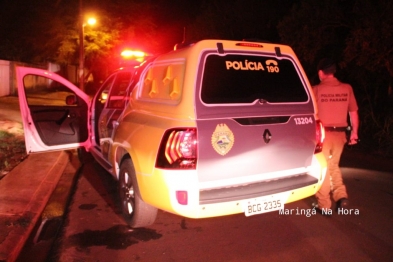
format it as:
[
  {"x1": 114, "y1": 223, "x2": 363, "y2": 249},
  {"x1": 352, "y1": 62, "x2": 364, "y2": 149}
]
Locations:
[{"x1": 50, "y1": 158, "x2": 393, "y2": 262}]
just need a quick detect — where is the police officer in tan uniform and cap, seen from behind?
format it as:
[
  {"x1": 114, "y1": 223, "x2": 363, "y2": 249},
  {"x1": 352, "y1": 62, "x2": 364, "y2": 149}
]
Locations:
[{"x1": 313, "y1": 58, "x2": 359, "y2": 215}]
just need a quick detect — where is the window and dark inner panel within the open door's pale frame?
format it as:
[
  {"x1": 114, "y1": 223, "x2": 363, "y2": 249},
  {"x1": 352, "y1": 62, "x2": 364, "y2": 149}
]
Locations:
[{"x1": 23, "y1": 75, "x2": 88, "y2": 146}]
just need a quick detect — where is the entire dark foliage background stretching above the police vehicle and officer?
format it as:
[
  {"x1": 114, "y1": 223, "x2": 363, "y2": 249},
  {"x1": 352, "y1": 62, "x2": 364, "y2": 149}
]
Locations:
[{"x1": 0, "y1": 0, "x2": 393, "y2": 155}]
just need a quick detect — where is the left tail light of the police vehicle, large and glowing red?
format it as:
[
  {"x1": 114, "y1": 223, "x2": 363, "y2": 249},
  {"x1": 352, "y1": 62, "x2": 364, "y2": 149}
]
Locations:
[{"x1": 156, "y1": 128, "x2": 198, "y2": 169}]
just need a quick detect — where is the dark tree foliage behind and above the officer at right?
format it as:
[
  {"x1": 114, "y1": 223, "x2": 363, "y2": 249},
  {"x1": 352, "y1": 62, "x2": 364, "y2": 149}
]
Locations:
[{"x1": 278, "y1": 0, "x2": 393, "y2": 155}]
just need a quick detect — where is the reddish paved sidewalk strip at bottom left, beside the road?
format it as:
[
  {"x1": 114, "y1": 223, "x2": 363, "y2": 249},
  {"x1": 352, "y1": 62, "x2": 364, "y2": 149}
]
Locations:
[{"x1": 0, "y1": 151, "x2": 70, "y2": 262}]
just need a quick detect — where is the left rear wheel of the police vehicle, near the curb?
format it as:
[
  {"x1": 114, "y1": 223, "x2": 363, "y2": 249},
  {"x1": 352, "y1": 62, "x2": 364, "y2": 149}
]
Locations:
[{"x1": 119, "y1": 158, "x2": 157, "y2": 228}]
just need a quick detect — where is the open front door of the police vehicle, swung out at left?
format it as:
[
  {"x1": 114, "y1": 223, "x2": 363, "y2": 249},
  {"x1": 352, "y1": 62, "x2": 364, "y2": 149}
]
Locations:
[{"x1": 16, "y1": 67, "x2": 90, "y2": 153}]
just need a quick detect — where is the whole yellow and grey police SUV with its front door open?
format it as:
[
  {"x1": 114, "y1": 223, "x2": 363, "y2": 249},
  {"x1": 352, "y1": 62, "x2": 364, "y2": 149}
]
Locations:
[{"x1": 17, "y1": 40, "x2": 326, "y2": 227}]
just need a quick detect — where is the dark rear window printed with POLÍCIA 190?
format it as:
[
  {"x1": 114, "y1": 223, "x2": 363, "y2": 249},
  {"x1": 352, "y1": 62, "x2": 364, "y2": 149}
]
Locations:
[{"x1": 201, "y1": 54, "x2": 308, "y2": 104}]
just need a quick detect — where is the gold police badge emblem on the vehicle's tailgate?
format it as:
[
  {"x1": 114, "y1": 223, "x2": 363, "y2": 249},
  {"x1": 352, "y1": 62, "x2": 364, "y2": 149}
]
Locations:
[{"x1": 212, "y1": 124, "x2": 235, "y2": 156}]
